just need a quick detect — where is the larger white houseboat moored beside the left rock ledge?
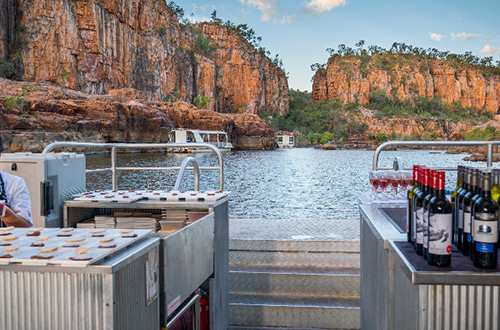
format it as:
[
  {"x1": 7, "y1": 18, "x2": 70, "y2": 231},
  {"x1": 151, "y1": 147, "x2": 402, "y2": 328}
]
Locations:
[{"x1": 169, "y1": 128, "x2": 234, "y2": 153}]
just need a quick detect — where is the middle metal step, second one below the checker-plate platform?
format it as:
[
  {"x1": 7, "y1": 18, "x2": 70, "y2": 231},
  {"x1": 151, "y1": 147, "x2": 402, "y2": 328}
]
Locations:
[{"x1": 229, "y1": 266, "x2": 360, "y2": 299}]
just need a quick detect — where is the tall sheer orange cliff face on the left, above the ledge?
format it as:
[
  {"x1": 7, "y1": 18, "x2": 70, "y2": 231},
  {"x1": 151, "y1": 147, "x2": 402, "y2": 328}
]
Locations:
[{"x1": 0, "y1": 0, "x2": 288, "y2": 114}]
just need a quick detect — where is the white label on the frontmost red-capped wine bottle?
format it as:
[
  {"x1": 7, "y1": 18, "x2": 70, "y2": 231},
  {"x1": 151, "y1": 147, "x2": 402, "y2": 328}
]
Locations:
[{"x1": 429, "y1": 213, "x2": 453, "y2": 255}]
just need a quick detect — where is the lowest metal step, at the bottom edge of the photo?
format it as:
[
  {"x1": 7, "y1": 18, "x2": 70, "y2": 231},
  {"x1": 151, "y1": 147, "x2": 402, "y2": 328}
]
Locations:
[{"x1": 229, "y1": 295, "x2": 360, "y2": 329}]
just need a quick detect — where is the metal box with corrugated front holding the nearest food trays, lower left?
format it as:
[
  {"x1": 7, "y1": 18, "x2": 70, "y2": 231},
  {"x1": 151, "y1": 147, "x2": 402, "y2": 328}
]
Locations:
[{"x1": 0, "y1": 237, "x2": 160, "y2": 330}]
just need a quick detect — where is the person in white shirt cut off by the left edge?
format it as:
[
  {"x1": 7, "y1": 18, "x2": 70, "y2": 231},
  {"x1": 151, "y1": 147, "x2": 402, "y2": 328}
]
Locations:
[{"x1": 0, "y1": 134, "x2": 33, "y2": 227}]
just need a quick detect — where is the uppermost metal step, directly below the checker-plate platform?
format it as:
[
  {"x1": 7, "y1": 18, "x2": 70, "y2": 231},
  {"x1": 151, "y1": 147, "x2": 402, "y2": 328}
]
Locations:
[{"x1": 229, "y1": 250, "x2": 360, "y2": 268}]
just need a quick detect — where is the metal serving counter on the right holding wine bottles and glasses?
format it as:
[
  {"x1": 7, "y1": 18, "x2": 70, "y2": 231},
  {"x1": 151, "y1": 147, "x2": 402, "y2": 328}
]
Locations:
[{"x1": 359, "y1": 204, "x2": 500, "y2": 330}]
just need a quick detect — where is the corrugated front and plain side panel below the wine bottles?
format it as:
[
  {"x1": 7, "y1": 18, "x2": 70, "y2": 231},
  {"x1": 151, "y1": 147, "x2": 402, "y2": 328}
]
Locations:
[{"x1": 391, "y1": 265, "x2": 500, "y2": 330}]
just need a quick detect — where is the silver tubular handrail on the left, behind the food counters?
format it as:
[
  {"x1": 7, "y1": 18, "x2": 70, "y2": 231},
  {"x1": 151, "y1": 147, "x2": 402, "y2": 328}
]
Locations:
[{"x1": 42, "y1": 142, "x2": 224, "y2": 190}]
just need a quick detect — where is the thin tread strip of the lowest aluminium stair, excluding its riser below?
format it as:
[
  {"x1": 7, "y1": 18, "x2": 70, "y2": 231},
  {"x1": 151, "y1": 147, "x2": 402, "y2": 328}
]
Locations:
[{"x1": 229, "y1": 294, "x2": 360, "y2": 310}]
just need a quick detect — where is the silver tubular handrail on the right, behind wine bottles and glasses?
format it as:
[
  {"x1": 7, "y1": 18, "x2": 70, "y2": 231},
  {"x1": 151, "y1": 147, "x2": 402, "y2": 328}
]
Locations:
[{"x1": 373, "y1": 141, "x2": 500, "y2": 171}]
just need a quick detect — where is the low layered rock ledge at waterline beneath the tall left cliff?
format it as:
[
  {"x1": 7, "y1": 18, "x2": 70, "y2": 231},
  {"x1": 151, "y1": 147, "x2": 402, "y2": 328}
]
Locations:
[{"x1": 0, "y1": 79, "x2": 275, "y2": 152}]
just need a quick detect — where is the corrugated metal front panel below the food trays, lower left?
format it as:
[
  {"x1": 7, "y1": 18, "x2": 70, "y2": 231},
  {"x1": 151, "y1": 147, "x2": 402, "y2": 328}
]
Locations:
[{"x1": 0, "y1": 271, "x2": 107, "y2": 330}]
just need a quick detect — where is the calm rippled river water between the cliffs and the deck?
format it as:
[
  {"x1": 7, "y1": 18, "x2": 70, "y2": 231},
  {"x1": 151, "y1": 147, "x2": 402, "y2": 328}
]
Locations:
[{"x1": 87, "y1": 148, "x2": 484, "y2": 219}]
